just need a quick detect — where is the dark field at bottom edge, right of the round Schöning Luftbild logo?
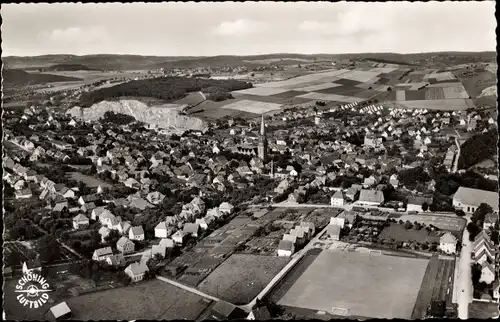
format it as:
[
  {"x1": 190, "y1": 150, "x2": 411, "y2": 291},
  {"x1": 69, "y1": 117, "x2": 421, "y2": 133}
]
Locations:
[{"x1": 66, "y1": 280, "x2": 210, "y2": 321}]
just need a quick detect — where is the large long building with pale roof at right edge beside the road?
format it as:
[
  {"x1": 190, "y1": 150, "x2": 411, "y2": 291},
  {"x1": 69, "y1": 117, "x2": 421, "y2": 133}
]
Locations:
[{"x1": 453, "y1": 187, "x2": 498, "y2": 214}]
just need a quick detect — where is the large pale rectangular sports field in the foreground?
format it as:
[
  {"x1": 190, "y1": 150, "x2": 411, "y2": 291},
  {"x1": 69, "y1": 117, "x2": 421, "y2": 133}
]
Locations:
[{"x1": 278, "y1": 251, "x2": 428, "y2": 319}]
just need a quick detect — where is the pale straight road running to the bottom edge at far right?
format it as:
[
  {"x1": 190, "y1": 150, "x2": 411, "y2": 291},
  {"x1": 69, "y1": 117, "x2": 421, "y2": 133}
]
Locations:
[{"x1": 455, "y1": 219, "x2": 473, "y2": 319}]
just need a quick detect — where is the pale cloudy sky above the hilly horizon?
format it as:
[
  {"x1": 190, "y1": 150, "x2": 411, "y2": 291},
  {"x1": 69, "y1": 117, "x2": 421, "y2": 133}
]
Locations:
[{"x1": 1, "y1": 1, "x2": 496, "y2": 56}]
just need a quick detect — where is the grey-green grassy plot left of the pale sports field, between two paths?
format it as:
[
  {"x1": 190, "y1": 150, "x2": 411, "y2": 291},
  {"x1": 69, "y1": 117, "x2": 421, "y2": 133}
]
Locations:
[{"x1": 198, "y1": 254, "x2": 289, "y2": 304}]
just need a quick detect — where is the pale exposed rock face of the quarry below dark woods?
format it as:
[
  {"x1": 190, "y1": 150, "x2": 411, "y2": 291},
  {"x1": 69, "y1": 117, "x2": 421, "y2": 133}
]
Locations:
[{"x1": 66, "y1": 100, "x2": 207, "y2": 131}]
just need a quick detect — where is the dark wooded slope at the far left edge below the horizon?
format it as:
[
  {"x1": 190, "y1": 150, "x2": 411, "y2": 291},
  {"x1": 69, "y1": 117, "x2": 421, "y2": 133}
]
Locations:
[{"x1": 2, "y1": 69, "x2": 82, "y2": 87}]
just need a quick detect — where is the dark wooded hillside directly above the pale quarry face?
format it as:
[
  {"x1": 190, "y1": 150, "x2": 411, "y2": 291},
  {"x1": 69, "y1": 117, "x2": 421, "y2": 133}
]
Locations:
[{"x1": 80, "y1": 77, "x2": 253, "y2": 107}]
